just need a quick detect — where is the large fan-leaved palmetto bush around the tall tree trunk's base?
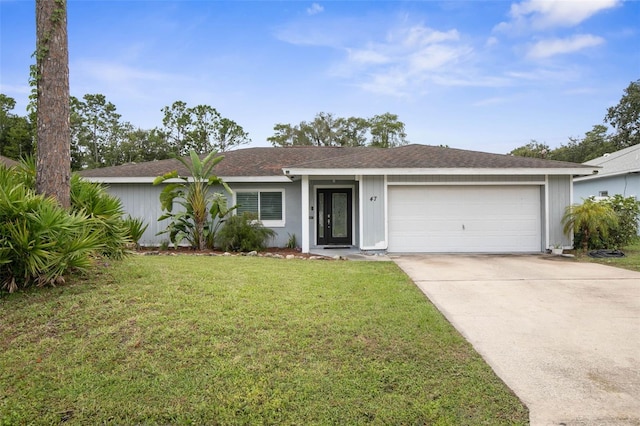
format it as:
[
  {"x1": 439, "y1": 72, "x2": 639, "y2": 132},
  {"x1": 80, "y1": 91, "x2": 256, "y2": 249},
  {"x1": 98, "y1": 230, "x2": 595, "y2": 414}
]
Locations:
[{"x1": 0, "y1": 161, "x2": 130, "y2": 292}]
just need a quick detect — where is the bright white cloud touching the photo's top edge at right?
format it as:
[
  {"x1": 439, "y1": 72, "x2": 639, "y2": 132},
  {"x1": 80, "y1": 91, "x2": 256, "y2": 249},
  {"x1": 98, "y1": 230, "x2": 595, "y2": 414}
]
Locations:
[{"x1": 494, "y1": 0, "x2": 621, "y2": 32}]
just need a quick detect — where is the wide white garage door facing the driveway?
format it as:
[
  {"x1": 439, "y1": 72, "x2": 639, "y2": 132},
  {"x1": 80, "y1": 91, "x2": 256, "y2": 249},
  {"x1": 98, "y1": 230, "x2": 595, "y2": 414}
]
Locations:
[{"x1": 389, "y1": 186, "x2": 541, "y2": 253}]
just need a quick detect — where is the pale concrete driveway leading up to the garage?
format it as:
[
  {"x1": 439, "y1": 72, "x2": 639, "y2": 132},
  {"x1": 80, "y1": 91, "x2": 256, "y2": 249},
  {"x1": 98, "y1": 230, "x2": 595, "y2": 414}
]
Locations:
[{"x1": 392, "y1": 255, "x2": 640, "y2": 425}]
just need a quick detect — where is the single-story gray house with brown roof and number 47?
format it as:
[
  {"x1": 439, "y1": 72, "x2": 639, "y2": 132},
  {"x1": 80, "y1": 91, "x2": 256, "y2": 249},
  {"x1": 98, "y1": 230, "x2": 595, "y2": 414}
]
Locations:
[{"x1": 80, "y1": 145, "x2": 596, "y2": 253}]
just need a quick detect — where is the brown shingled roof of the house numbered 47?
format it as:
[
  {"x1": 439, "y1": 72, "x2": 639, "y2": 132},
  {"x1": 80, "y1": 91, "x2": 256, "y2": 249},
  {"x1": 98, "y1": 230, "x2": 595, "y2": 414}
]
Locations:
[{"x1": 80, "y1": 145, "x2": 593, "y2": 178}]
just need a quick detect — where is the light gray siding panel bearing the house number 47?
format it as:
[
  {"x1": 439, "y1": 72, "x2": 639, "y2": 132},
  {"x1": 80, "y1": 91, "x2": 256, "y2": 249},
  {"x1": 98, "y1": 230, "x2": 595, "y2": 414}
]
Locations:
[{"x1": 360, "y1": 176, "x2": 387, "y2": 250}]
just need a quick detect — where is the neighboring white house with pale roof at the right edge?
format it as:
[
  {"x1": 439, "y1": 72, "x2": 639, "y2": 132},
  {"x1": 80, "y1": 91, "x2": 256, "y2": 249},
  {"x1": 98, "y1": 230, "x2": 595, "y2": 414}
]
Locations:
[{"x1": 573, "y1": 145, "x2": 640, "y2": 234}]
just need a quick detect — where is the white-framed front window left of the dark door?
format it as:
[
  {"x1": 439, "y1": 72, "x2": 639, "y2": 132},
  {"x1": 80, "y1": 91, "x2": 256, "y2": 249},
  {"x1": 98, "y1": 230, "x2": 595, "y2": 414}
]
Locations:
[{"x1": 236, "y1": 190, "x2": 284, "y2": 227}]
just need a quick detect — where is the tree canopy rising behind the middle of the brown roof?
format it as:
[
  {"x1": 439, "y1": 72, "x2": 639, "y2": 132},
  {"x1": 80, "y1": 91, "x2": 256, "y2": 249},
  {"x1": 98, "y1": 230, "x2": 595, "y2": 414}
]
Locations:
[{"x1": 267, "y1": 112, "x2": 407, "y2": 148}]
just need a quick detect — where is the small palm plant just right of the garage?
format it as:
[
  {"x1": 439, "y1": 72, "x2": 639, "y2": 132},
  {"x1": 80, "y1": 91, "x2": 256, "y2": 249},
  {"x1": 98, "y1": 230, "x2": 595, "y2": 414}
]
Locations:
[{"x1": 562, "y1": 198, "x2": 618, "y2": 251}]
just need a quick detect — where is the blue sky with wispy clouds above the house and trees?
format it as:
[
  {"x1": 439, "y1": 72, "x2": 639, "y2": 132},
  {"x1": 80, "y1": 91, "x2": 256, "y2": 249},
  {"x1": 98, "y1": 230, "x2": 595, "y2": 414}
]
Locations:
[{"x1": 0, "y1": 0, "x2": 640, "y2": 153}]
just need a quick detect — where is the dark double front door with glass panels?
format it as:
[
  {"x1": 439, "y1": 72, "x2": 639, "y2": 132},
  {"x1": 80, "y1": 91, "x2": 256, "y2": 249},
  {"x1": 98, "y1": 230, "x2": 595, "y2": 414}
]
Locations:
[{"x1": 316, "y1": 188, "x2": 353, "y2": 245}]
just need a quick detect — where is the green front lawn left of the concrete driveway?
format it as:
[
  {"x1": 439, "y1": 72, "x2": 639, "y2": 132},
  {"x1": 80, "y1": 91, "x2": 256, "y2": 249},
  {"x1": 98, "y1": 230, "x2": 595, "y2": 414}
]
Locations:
[{"x1": 0, "y1": 256, "x2": 528, "y2": 425}]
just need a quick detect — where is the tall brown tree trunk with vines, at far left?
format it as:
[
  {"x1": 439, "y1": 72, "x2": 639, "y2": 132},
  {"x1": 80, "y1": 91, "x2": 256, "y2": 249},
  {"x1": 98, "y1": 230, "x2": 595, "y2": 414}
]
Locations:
[{"x1": 36, "y1": 0, "x2": 71, "y2": 207}]
